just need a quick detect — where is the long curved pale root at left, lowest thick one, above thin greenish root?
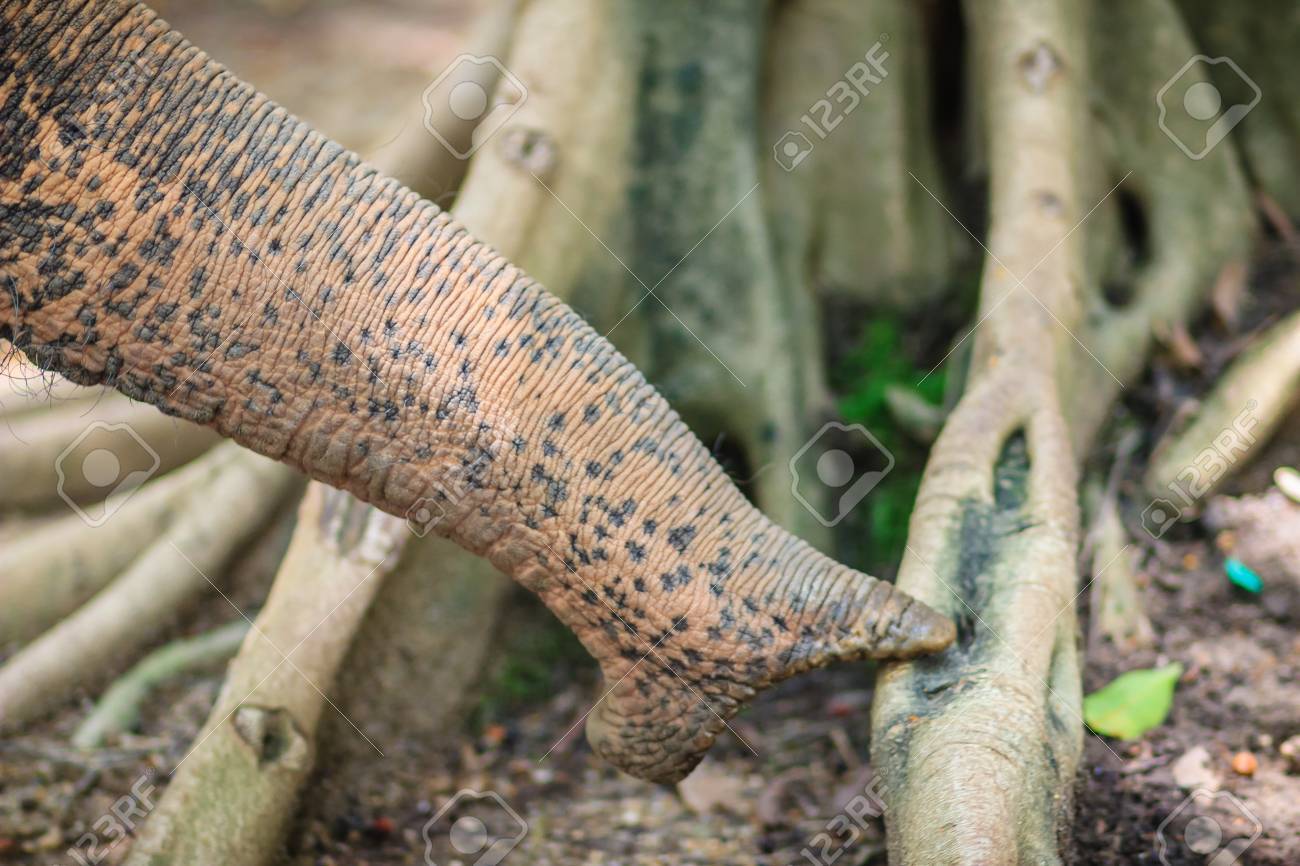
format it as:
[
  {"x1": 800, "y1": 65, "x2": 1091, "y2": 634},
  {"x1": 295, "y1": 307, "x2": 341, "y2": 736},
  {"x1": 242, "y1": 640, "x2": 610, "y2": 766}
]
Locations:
[{"x1": 0, "y1": 444, "x2": 298, "y2": 729}]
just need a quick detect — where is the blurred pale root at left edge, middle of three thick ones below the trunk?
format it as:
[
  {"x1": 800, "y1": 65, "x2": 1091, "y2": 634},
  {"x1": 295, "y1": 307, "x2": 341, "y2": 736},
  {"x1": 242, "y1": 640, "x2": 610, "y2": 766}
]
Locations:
[{"x1": 0, "y1": 451, "x2": 245, "y2": 644}]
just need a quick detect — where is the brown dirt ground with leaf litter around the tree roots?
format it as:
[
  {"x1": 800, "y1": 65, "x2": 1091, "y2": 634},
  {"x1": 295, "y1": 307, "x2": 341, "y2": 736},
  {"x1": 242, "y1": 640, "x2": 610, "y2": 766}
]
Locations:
[{"x1": 0, "y1": 1, "x2": 1300, "y2": 866}]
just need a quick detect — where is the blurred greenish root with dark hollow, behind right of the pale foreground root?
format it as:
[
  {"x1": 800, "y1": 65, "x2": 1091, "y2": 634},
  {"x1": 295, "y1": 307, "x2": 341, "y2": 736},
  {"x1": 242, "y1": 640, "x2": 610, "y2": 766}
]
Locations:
[{"x1": 1062, "y1": 0, "x2": 1255, "y2": 444}]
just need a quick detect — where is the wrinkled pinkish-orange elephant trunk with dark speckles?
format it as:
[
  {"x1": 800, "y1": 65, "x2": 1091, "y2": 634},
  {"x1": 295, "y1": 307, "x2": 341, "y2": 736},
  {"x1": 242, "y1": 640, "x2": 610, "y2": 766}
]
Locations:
[{"x1": 0, "y1": 1, "x2": 953, "y2": 780}]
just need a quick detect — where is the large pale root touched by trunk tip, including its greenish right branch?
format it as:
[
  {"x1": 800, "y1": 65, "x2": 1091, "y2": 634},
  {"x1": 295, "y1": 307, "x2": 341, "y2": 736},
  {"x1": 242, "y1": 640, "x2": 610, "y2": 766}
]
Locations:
[{"x1": 874, "y1": 3, "x2": 1249, "y2": 866}]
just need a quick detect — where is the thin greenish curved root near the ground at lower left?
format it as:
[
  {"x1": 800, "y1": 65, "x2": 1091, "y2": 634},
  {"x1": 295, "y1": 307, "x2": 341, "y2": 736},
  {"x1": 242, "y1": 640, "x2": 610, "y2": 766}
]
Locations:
[{"x1": 72, "y1": 619, "x2": 248, "y2": 749}]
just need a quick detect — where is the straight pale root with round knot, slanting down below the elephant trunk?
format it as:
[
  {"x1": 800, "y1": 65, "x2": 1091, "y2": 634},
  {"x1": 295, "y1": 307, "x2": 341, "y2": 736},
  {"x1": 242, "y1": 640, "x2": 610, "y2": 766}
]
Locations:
[{"x1": 126, "y1": 485, "x2": 410, "y2": 866}]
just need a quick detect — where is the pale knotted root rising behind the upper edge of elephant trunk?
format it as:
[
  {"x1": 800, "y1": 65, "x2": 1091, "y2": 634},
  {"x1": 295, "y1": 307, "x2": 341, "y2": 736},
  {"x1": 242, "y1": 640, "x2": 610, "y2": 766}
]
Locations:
[{"x1": 452, "y1": 0, "x2": 644, "y2": 317}]
